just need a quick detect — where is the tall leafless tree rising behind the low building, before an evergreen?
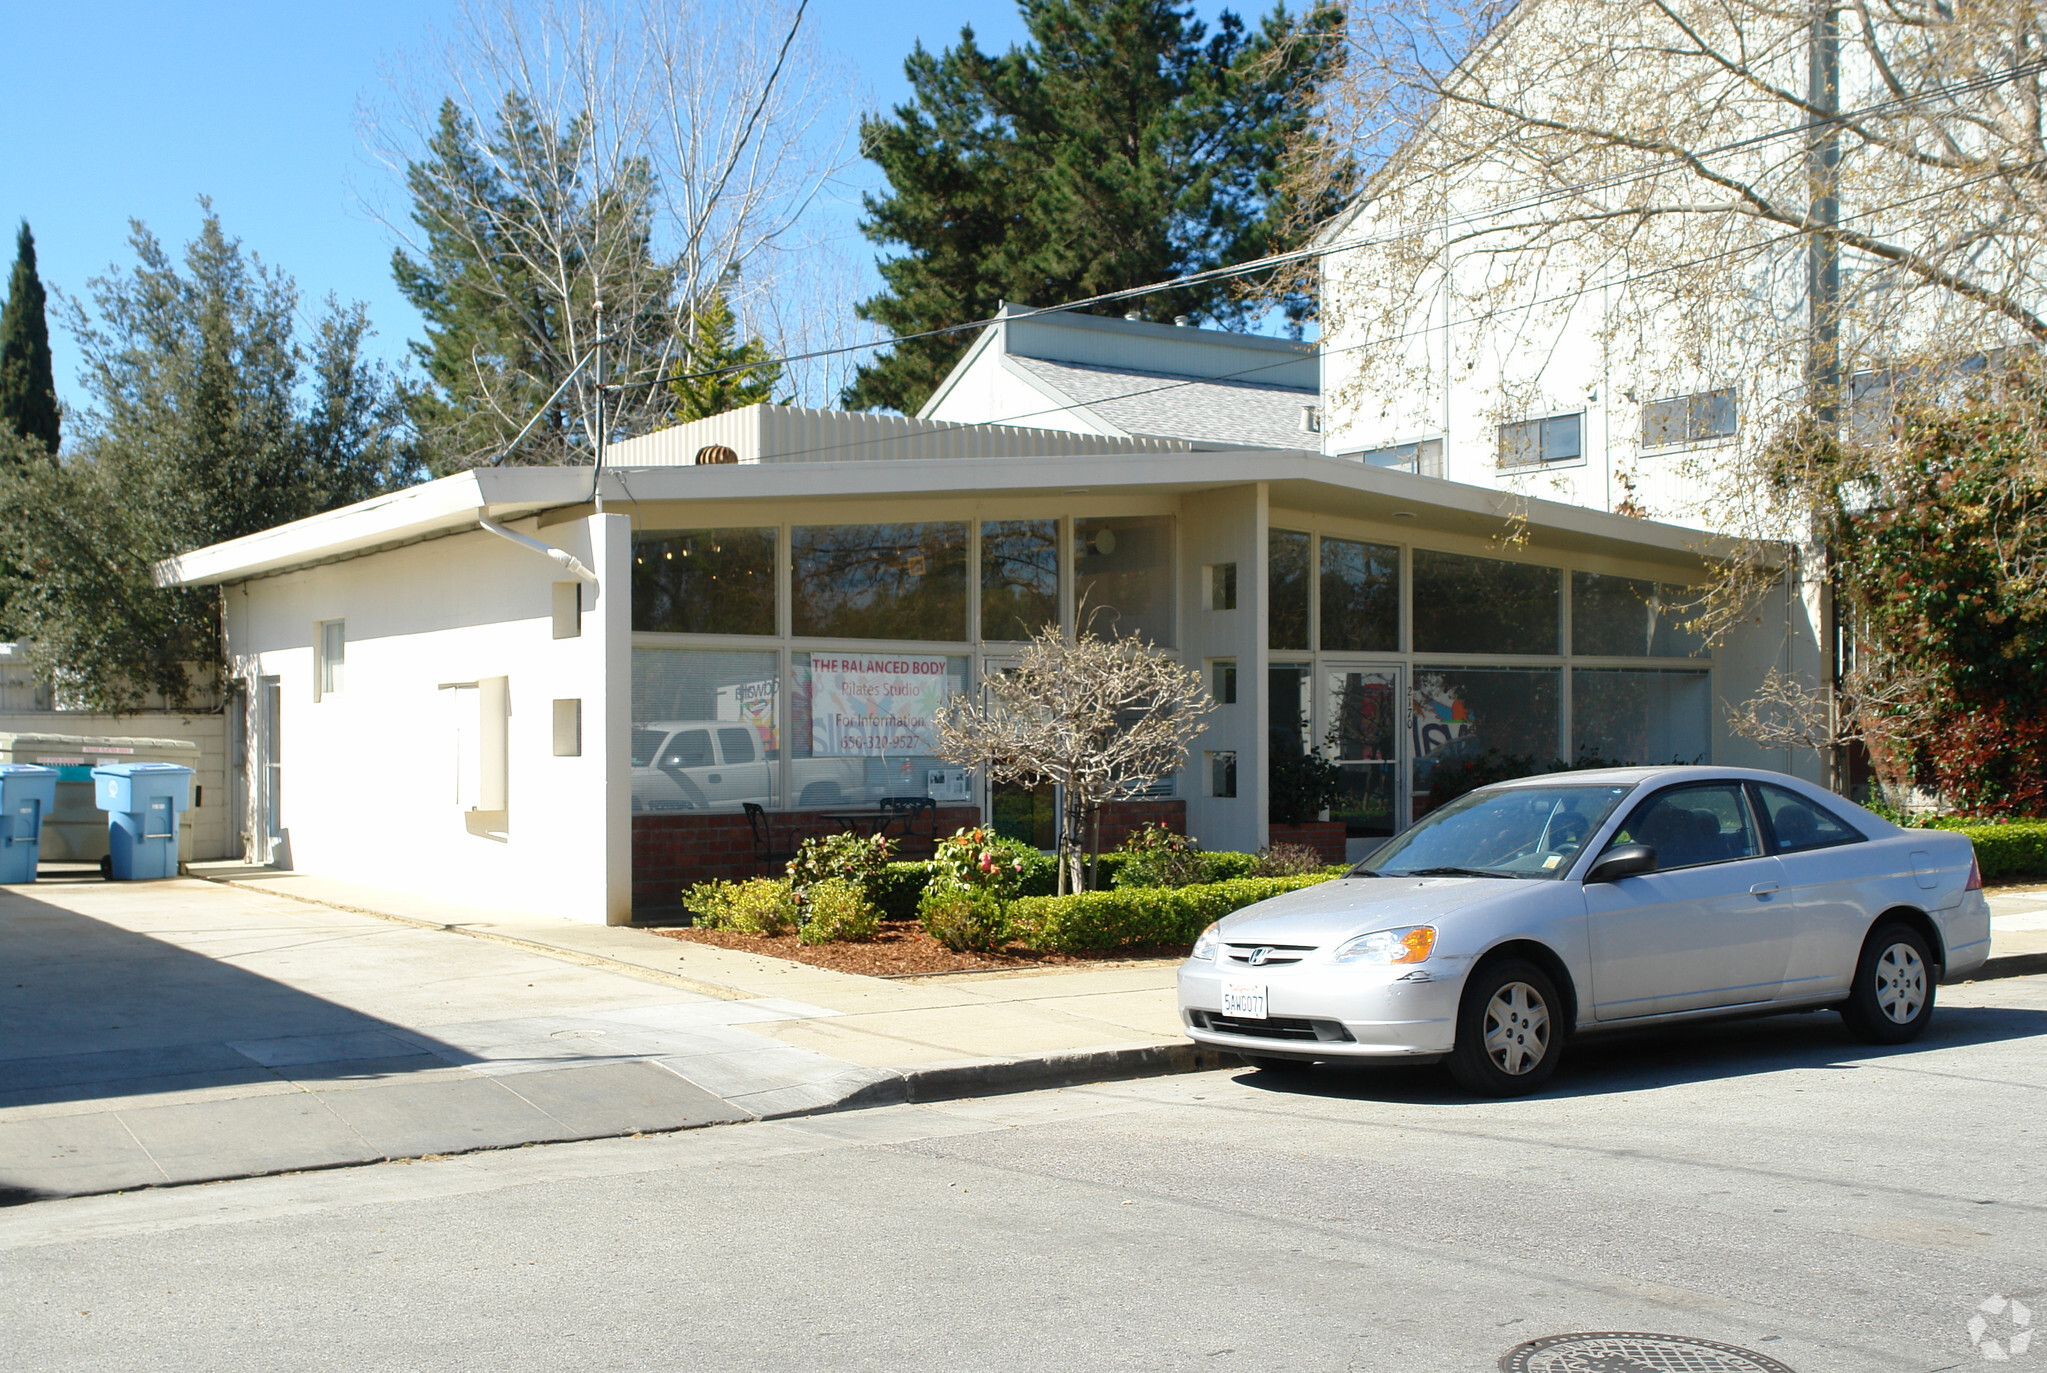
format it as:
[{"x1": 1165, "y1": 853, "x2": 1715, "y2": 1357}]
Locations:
[{"x1": 362, "y1": 0, "x2": 854, "y2": 467}]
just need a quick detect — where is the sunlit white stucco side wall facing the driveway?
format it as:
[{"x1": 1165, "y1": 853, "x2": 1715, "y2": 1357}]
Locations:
[{"x1": 227, "y1": 516, "x2": 630, "y2": 923}]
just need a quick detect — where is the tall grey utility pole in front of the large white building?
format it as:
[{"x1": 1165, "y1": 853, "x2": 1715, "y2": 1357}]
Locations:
[{"x1": 1805, "y1": 0, "x2": 1842, "y2": 792}]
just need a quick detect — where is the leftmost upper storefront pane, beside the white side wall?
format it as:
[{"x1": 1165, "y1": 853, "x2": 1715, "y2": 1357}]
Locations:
[{"x1": 633, "y1": 528, "x2": 776, "y2": 634}]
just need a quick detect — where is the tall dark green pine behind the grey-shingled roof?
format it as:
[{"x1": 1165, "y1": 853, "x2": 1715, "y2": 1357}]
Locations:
[{"x1": 843, "y1": 0, "x2": 1339, "y2": 413}]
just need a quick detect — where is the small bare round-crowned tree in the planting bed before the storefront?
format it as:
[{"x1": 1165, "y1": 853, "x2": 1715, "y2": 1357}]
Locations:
[{"x1": 938, "y1": 626, "x2": 1216, "y2": 892}]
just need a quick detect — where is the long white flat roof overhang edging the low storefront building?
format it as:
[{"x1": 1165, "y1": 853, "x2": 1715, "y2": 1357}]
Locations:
[{"x1": 156, "y1": 448, "x2": 1760, "y2": 587}]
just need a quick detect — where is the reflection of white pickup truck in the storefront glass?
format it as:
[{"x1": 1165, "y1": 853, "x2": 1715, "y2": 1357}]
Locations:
[{"x1": 633, "y1": 720, "x2": 884, "y2": 810}]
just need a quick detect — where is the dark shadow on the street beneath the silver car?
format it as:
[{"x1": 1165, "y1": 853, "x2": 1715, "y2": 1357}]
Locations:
[{"x1": 1236, "y1": 1007, "x2": 2047, "y2": 1107}]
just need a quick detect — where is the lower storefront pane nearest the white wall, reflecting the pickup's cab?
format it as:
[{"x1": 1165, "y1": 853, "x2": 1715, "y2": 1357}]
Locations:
[{"x1": 633, "y1": 649, "x2": 782, "y2": 812}]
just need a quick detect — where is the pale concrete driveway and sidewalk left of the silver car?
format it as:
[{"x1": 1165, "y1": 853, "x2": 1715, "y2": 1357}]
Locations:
[{"x1": 0, "y1": 874, "x2": 1226, "y2": 1199}]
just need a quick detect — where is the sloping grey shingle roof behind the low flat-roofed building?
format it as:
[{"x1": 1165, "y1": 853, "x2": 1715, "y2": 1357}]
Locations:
[{"x1": 1005, "y1": 354, "x2": 1316, "y2": 448}]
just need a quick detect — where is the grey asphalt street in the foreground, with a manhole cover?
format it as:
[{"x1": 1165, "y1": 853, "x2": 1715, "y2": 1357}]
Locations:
[{"x1": 0, "y1": 978, "x2": 2047, "y2": 1373}]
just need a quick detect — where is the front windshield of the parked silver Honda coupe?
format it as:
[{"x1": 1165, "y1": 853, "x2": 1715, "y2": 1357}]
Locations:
[{"x1": 1353, "y1": 786, "x2": 1634, "y2": 878}]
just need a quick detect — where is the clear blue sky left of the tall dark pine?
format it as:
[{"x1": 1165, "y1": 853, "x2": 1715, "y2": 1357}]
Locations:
[{"x1": 0, "y1": 0, "x2": 1056, "y2": 415}]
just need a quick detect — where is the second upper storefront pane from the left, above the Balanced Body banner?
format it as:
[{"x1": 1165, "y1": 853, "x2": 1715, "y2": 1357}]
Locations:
[{"x1": 790, "y1": 524, "x2": 966, "y2": 640}]
